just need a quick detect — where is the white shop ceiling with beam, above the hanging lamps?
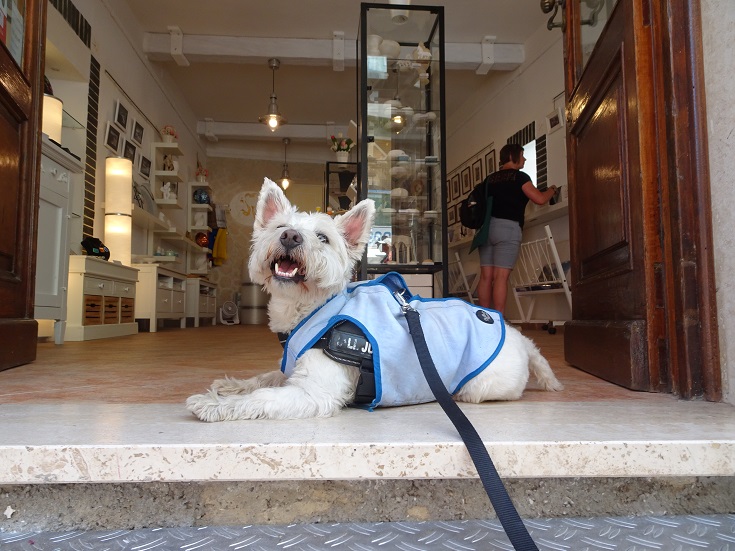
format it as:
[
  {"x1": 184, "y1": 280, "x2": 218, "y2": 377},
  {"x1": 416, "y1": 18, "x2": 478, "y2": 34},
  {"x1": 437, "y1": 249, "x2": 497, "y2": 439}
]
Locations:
[{"x1": 118, "y1": 0, "x2": 548, "y2": 151}]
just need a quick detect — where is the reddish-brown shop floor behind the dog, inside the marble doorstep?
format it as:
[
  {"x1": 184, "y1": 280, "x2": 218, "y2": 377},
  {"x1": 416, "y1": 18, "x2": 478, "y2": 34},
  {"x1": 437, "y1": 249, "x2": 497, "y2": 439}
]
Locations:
[{"x1": 0, "y1": 325, "x2": 675, "y2": 404}]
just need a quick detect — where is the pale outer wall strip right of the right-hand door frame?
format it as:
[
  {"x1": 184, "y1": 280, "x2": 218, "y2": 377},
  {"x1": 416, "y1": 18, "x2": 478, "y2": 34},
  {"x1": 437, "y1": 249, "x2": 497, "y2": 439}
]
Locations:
[{"x1": 701, "y1": 0, "x2": 735, "y2": 404}]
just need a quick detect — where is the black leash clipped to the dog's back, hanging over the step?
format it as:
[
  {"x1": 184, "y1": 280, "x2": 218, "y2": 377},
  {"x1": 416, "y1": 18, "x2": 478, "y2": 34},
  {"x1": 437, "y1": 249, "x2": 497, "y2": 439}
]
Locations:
[{"x1": 395, "y1": 293, "x2": 538, "y2": 551}]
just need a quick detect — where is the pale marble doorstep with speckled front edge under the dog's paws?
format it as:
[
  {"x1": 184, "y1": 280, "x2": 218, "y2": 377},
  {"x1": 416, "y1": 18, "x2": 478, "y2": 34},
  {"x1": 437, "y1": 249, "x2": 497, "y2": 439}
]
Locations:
[{"x1": 0, "y1": 399, "x2": 735, "y2": 484}]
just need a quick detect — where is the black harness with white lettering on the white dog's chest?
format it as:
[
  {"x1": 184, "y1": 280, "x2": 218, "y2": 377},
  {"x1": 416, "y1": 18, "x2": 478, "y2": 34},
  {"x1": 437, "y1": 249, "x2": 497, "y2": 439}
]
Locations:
[{"x1": 278, "y1": 320, "x2": 375, "y2": 405}]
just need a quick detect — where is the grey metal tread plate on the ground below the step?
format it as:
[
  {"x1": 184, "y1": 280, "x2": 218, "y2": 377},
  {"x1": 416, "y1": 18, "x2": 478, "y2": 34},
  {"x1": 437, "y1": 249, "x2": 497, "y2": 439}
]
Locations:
[{"x1": 0, "y1": 515, "x2": 735, "y2": 551}]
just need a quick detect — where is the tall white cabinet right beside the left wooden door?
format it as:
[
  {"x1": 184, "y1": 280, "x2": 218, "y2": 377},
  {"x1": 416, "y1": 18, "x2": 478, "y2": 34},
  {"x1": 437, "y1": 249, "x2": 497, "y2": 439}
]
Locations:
[{"x1": 34, "y1": 135, "x2": 82, "y2": 344}]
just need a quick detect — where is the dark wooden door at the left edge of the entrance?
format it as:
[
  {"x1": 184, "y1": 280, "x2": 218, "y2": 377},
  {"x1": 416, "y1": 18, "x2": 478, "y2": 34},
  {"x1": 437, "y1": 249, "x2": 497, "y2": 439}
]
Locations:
[{"x1": 0, "y1": 0, "x2": 46, "y2": 369}]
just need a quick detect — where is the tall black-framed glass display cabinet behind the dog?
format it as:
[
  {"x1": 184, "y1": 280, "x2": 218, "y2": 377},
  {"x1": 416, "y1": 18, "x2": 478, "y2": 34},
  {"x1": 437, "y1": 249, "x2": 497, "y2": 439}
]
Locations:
[{"x1": 357, "y1": 3, "x2": 447, "y2": 296}]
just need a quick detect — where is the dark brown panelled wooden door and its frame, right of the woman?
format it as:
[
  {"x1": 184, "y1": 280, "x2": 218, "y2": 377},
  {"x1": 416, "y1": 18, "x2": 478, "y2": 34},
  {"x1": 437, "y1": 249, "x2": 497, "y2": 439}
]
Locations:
[{"x1": 564, "y1": 0, "x2": 720, "y2": 399}]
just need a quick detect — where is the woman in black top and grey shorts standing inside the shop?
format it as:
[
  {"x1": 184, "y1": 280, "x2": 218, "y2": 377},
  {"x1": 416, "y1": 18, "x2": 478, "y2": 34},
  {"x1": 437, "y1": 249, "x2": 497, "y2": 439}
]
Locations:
[{"x1": 477, "y1": 144, "x2": 556, "y2": 314}]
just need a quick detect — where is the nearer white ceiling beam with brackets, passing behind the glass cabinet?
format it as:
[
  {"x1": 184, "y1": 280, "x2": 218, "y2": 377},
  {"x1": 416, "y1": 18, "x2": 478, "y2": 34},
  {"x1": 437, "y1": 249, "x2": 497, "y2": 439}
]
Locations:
[{"x1": 143, "y1": 33, "x2": 525, "y2": 74}]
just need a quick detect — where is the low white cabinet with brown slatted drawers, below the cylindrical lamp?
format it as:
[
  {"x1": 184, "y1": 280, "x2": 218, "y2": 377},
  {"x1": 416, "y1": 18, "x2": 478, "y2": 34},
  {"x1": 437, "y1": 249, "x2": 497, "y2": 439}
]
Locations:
[{"x1": 66, "y1": 255, "x2": 138, "y2": 341}]
